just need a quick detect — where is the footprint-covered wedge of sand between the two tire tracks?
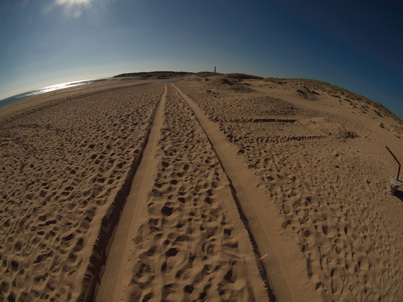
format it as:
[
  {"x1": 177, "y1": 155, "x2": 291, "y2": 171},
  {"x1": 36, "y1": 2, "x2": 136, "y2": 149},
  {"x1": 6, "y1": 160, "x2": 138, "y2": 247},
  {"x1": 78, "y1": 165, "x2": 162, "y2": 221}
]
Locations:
[{"x1": 96, "y1": 87, "x2": 269, "y2": 301}]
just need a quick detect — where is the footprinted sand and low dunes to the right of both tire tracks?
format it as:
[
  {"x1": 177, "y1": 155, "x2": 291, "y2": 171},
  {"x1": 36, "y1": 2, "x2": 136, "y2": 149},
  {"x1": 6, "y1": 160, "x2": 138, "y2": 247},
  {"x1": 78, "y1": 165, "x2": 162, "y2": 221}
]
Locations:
[{"x1": 176, "y1": 76, "x2": 403, "y2": 301}]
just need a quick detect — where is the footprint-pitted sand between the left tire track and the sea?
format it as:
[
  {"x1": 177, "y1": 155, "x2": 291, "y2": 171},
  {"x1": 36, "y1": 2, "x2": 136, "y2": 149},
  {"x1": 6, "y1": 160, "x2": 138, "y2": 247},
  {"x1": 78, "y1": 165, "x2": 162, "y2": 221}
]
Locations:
[{"x1": 0, "y1": 82, "x2": 162, "y2": 301}]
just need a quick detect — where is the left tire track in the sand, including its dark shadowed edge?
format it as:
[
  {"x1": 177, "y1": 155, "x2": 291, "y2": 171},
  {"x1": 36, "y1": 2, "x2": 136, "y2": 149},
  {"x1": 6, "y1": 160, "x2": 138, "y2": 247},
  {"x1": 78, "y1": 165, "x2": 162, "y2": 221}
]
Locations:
[{"x1": 94, "y1": 85, "x2": 167, "y2": 301}]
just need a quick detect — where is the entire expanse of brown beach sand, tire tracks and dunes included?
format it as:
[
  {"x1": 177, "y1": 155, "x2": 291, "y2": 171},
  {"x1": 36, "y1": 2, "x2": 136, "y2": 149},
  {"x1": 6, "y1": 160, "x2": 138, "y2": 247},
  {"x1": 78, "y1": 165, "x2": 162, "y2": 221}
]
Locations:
[{"x1": 0, "y1": 75, "x2": 403, "y2": 301}]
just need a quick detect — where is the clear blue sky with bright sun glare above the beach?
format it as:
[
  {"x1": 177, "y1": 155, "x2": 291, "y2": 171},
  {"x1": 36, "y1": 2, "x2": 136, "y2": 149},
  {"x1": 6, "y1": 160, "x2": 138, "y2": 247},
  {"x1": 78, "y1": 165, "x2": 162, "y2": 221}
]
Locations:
[{"x1": 0, "y1": 0, "x2": 403, "y2": 118}]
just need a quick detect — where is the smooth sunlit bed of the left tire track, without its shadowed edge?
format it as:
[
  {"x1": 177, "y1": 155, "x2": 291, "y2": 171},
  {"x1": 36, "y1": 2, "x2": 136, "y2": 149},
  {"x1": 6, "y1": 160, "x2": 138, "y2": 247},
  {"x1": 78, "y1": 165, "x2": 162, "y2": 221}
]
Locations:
[{"x1": 95, "y1": 85, "x2": 167, "y2": 301}]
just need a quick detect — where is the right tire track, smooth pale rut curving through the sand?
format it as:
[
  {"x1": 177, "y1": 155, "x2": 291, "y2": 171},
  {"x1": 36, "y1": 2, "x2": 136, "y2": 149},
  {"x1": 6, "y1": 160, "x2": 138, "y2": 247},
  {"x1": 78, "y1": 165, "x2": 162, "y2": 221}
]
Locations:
[{"x1": 173, "y1": 85, "x2": 321, "y2": 301}]
